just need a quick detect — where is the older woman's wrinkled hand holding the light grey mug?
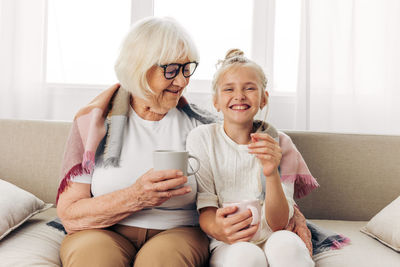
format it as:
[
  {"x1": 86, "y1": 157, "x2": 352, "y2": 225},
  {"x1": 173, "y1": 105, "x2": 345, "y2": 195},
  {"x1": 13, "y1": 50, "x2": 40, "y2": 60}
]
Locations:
[{"x1": 131, "y1": 169, "x2": 192, "y2": 208}]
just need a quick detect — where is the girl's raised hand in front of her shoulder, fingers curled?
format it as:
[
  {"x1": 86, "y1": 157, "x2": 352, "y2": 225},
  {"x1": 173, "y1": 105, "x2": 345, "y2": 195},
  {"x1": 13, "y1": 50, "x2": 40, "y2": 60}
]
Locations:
[{"x1": 248, "y1": 133, "x2": 282, "y2": 177}]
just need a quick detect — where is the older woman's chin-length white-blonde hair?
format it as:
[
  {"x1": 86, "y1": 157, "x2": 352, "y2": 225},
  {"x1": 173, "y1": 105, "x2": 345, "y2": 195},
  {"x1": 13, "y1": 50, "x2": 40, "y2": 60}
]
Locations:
[{"x1": 114, "y1": 17, "x2": 199, "y2": 99}]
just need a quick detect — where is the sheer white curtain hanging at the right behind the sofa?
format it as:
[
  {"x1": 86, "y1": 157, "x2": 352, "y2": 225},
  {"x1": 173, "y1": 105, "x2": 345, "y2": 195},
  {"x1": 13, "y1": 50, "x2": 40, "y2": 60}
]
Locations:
[{"x1": 296, "y1": 0, "x2": 400, "y2": 134}]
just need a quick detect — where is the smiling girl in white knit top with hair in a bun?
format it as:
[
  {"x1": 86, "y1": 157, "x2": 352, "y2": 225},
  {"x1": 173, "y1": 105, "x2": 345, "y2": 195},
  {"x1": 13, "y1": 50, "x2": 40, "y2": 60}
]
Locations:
[{"x1": 186, "y1": 49, "x2": 314, "y2": 267}]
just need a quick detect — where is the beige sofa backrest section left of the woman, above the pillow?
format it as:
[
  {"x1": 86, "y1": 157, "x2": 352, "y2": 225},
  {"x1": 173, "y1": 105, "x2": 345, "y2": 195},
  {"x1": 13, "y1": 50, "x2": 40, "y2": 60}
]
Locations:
[{"x1": 0, "y1": 120, "x2": 72, "y2": 203}]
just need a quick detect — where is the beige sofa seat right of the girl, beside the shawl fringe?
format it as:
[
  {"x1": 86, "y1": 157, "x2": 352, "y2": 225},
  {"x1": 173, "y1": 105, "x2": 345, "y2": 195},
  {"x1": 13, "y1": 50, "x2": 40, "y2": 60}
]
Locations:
[{"x1": 311, "y1": 220, "x2": 400, "y2": 267}]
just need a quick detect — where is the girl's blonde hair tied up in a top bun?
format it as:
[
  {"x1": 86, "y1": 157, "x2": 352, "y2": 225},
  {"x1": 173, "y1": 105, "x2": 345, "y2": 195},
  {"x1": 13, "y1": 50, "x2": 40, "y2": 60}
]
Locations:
[{"x1": 212, "y1": 48, "x2": 268, "y2": 97}]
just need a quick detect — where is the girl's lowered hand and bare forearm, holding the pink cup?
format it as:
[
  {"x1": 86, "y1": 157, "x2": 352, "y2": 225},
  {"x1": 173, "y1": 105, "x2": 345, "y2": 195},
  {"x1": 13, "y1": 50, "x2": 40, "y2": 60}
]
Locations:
[{"x1": 200, "y1": 206, "x2": 259, "y2": 244}]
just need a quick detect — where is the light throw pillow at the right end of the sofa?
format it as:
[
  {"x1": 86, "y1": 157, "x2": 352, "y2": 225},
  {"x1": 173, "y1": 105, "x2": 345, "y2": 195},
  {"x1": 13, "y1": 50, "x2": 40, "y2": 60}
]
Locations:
[{"x1": 361, "y1": 197, "x2": 400, "y2": 252}]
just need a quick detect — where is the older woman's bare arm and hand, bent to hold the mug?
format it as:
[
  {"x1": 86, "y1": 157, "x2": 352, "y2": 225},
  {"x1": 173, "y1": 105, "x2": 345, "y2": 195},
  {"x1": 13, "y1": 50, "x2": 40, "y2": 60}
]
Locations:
[{"x1": 57, "y1": 170, "x2": 191, "y2": 233}]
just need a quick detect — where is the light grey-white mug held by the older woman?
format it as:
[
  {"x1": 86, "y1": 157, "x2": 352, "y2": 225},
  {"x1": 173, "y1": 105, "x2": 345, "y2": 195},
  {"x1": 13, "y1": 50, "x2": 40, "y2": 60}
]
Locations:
[{"x1": 153, "y1": 150, "x2": 200, "y2": 176}]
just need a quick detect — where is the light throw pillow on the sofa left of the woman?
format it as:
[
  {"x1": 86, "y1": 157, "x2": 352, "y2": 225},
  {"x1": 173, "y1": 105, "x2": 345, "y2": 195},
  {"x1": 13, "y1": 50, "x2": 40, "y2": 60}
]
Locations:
[{"x1": 0, "y1": 179, "x2": 52, "y2": 240}]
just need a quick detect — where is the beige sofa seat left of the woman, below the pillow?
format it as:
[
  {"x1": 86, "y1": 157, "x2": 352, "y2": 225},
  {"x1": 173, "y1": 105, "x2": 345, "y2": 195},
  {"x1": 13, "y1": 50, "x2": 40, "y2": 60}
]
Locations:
[{"x1": 0, "y1": 208, "x2": 65, "y2": 266}]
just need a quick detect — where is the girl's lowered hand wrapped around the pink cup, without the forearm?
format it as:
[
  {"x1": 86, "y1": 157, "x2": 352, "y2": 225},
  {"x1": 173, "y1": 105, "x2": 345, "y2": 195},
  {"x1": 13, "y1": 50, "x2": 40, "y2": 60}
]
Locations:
[{"x1": 213, "y1": 206, "x2": 259, "y2": 244}]
